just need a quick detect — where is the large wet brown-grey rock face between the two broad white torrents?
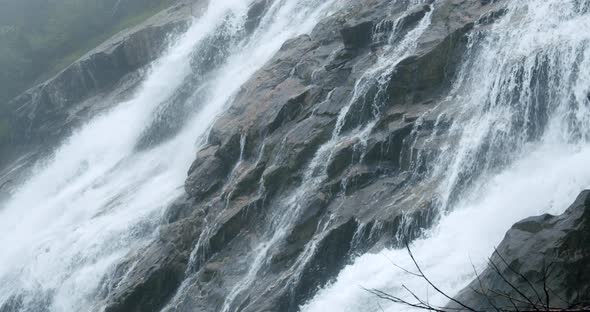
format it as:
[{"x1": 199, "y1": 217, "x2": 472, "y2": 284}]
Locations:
[{"x1": 98, "y1": 0, "x2": 512, "y2": 311}]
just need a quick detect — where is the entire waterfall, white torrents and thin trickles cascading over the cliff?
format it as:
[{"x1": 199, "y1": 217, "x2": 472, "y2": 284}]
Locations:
[{"x1": 0, "y1": 0, "x2": 590, "y2": 312}]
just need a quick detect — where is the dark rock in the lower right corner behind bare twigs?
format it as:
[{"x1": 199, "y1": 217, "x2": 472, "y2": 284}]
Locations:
[{"x1": 456, "y1": 191, "x2": 590, "y2": 310}]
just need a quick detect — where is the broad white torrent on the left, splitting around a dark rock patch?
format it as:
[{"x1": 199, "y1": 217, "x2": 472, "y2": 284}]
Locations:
[{"x1": 0, "y1": 0, "x2": 342, "y2": 311}]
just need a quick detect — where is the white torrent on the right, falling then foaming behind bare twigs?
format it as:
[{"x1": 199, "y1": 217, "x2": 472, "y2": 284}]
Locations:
[{"x1": 302, "y1": 0, "x2": 590, "y2": 312}]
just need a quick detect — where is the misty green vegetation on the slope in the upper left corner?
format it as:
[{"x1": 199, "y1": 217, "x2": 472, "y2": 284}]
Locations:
[{"x1": 0, "y1": 0, "x2": 178, "y2": 103}]
